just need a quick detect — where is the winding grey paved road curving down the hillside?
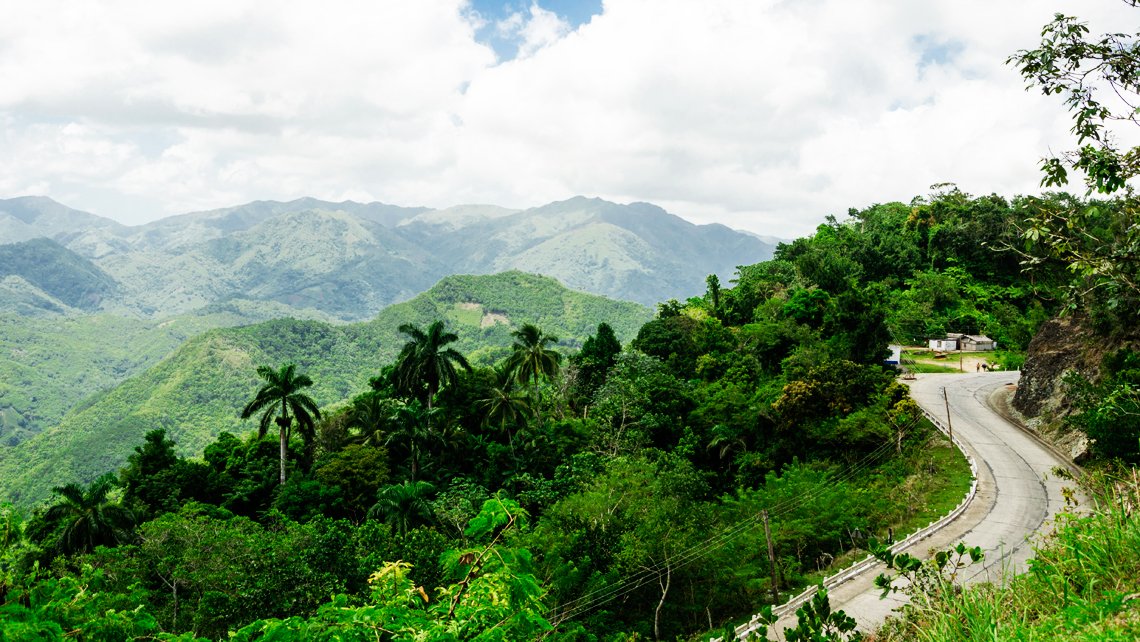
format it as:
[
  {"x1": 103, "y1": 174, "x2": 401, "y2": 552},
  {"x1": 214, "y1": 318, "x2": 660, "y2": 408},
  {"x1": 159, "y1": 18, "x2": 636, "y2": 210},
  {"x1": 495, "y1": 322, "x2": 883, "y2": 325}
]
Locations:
[{"x1": 773, "y1": 373, "x2": 1072, "y2": 639}]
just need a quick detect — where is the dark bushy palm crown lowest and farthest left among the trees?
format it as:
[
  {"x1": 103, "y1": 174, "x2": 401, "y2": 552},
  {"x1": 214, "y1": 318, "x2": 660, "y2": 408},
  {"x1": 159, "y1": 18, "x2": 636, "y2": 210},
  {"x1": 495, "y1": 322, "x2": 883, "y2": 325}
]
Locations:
[{"x1": 43, "y1": 472, "x2": 135, "y2": 553}]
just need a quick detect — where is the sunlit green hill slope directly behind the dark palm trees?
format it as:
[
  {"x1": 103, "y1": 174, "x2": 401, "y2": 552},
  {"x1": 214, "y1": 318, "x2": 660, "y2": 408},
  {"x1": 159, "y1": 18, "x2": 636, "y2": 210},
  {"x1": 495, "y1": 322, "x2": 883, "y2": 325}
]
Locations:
[{"x1": 0, "y1": 273, "x2": 652, "y2": 505}]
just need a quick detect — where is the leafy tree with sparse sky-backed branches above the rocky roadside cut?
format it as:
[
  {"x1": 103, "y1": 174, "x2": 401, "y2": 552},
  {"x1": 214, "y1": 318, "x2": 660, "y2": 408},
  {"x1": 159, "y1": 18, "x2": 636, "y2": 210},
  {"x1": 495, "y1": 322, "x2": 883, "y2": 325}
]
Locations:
[{"x1": 1007, "y1": 5, "x2": 1140, "y2": 319}]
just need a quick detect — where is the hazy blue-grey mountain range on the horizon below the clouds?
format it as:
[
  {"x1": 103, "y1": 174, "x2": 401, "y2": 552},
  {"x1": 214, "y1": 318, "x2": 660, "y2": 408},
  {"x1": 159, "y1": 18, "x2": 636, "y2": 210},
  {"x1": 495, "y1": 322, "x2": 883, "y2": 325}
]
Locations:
[{"x1": 0, "y1": 196, "x2": 773, "y2": 320}]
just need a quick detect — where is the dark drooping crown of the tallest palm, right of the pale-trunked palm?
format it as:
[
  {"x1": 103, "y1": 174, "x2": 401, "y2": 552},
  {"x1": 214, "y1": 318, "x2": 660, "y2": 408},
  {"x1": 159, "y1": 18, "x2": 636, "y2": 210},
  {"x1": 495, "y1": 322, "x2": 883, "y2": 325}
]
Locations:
[{"x1": 393, "y1": 320, "x2": 471, "y2": 412}]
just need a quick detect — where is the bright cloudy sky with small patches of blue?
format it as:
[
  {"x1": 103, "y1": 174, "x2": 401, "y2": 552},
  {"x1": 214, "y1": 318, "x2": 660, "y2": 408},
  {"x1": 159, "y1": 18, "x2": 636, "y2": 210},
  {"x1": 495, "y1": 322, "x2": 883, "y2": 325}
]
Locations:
[{"x1": 0, "y1": 0, "x2": 1140, "y2": 242}]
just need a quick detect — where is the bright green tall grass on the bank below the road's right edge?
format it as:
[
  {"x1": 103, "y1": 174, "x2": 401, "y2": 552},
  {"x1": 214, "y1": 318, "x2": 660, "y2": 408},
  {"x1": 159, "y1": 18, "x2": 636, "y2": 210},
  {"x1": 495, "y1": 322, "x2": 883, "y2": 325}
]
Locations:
[{"x1": 876, "y1": 469, "x2": 1140, "y2": 642}]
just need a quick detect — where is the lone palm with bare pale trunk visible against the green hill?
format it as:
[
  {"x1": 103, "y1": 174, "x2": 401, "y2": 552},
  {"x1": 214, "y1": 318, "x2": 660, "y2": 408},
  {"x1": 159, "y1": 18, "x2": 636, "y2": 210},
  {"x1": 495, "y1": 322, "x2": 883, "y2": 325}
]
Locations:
[{"x1": 242, "y1": 364, "x2": 320, "y2": 483}]
